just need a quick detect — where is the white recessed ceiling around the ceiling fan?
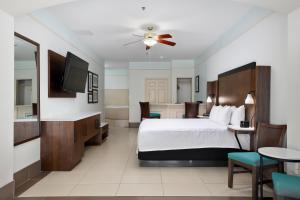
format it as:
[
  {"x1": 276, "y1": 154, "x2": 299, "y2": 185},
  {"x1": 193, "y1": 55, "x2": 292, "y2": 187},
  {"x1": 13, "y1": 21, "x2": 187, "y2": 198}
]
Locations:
[{"x1": 46, "y1": 0, "x2": 252, "y2": 61}]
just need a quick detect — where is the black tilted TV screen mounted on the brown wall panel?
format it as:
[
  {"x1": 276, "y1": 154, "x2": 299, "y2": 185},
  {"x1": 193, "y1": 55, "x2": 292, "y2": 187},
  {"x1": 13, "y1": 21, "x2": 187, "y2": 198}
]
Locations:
[{"x1": 63, "y1": 52, "x2": 89, "y2": 93}]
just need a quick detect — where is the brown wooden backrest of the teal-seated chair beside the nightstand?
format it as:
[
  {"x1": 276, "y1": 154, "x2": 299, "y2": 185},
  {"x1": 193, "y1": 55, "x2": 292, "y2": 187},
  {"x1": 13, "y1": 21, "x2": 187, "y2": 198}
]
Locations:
[{"x1": 254, "y1": 123, "x2": 287, "y2": 151}]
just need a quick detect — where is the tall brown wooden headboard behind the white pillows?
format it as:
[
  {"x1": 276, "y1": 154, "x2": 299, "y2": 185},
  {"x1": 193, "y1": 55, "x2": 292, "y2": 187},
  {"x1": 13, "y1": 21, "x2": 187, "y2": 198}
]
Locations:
[{"x1": 217, "y1": 62, "x2": 271, "y2": 125}]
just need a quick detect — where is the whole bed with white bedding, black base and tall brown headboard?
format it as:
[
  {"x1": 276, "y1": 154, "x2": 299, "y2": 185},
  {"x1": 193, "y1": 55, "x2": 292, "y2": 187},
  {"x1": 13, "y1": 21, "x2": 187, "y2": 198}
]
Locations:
[{"x1": 137, "y1": 62, "x2": 271, "y2": 166}]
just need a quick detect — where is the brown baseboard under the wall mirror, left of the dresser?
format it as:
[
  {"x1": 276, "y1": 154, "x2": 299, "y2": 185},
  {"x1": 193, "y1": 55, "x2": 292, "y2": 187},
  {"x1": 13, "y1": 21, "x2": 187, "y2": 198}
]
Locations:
[{"x1": 14, "y1": 160, "x2": 42, "y2": 190}]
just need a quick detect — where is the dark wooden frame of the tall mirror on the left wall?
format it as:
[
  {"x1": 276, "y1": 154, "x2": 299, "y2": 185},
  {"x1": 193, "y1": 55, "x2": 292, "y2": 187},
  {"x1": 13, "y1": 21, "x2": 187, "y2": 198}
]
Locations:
[{"x1": 14, "y1": 32, "x2": 41, "y2": 146}]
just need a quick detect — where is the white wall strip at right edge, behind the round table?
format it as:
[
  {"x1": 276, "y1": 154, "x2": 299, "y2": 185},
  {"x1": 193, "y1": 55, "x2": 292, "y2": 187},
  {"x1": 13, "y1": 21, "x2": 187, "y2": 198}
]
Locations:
[{"x1": 283, "y1": 9, "x2": 300, "y2": 174}]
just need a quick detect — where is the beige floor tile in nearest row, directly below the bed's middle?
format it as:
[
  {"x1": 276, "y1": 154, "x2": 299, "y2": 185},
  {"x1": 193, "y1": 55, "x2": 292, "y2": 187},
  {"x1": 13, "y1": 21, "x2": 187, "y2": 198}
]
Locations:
[{"x1": 163, "y1": 183, "x2": 210, "y2": 196}]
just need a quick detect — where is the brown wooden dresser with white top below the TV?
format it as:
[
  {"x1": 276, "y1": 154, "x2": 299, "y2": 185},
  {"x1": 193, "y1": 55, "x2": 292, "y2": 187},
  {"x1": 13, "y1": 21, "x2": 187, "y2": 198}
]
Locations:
[{"x1": 41, "y1": 112, "x2": 102, "y2": 171}]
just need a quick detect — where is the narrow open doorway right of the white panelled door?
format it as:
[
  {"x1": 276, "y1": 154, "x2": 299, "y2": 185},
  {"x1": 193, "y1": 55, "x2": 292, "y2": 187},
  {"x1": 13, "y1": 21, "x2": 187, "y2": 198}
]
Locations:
[{"x1": 177, "y1": 78, "x2": 192, "y2": 103}]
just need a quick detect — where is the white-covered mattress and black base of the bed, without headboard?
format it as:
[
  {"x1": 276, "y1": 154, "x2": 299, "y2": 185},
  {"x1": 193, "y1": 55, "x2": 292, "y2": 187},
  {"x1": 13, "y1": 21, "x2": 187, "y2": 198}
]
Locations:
[{"x1": 138, "y1": 119, "x2": 250, "y2": 161}]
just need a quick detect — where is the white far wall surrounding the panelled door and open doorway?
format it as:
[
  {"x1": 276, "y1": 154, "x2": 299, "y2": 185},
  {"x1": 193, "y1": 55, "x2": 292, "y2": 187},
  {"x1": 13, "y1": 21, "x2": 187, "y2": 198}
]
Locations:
[{"x1": 128, "y1": 60, "x2": 195, "y2": 122}]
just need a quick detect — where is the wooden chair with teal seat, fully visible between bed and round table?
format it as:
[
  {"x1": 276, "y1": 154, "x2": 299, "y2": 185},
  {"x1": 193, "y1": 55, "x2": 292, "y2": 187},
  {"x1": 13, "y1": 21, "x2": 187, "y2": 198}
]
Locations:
[{"x1": 228, "y1": 123, "x2": 286, "y2": 199}]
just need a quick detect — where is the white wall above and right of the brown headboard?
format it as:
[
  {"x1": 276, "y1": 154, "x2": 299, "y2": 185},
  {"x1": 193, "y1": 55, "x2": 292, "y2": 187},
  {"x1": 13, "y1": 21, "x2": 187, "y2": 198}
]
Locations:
[{"x1": 197, "y1": 14, "x2": 287, "y2": 123}]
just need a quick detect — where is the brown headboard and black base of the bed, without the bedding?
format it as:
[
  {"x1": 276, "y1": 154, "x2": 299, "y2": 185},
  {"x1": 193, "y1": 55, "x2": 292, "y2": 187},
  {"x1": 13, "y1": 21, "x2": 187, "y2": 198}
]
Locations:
[{"x1": 138, "y1": 62, "x2": 271, "y2": 166}]
